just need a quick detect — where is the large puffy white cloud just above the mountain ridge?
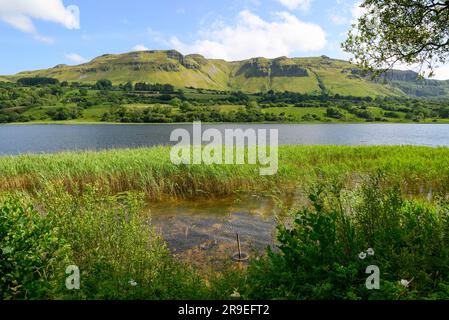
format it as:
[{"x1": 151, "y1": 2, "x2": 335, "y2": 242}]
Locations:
[{"x1": 170, "y1": 10, "x2": 327, "y2": 60}]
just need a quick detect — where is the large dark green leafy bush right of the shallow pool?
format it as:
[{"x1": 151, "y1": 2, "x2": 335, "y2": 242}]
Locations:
[{"x1": 245, "y1": 175, "x2": 449, "y2": 300}]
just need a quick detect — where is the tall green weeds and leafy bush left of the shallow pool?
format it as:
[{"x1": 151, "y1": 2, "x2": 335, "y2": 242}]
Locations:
[{"x1": 0, "y1": 188, "x2": 206, "y2": 300}]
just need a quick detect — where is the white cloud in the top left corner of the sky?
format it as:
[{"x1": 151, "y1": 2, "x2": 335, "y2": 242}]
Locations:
[{"x1": 0, "y1": 0, "x2": 80, "y2": 35}]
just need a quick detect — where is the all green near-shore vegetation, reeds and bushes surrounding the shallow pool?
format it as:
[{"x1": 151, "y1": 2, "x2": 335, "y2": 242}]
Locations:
[{"x1": 0, "y1": 147, "x2": 449, "y2": 300}]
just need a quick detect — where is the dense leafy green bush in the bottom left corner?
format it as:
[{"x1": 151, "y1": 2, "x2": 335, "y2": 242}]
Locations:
[{"x1": 0, "y1": 198, "x2": 70, "y2": 300}]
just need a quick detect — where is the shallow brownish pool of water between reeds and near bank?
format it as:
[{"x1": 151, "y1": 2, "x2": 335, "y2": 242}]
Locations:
[{"x1": 148, "y1": 195, "x2": 278, "y2": 254}]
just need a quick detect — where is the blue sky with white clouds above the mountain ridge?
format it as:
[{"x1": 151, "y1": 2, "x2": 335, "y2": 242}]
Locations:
[{"x1": 0, "y1": 0, "x2": 449, "y2": 79}]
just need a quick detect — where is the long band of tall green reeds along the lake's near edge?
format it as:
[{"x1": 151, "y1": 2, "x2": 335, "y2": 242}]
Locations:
[{"x1": 0, "y1": 146, "x2": 449, "y2": 200}]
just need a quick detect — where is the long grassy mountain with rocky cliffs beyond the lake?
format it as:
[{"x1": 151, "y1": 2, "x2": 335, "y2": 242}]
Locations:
[{"x1": 3, "y1": 50, "x2": 449, "y2": 96}]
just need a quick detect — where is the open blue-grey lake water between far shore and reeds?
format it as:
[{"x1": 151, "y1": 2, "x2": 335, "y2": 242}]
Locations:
[{"x1": 0, "y1": 124, "x2": 449, "y2": 155}]
